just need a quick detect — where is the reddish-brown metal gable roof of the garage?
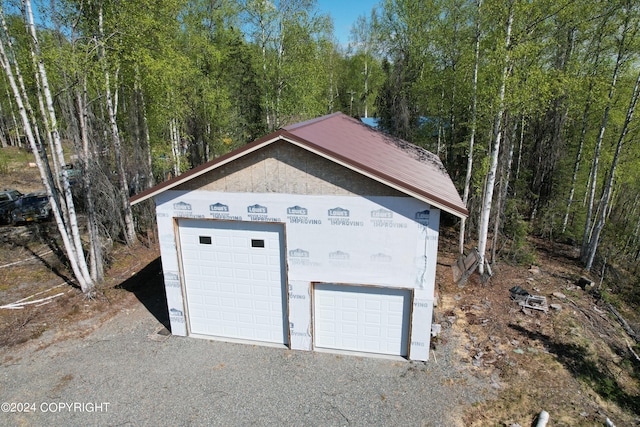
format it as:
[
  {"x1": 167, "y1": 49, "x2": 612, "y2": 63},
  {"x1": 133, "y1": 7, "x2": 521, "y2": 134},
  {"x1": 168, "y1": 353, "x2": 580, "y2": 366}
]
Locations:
[{"x1": 131, "y1": 113, "x2": 468, "y2": 217}]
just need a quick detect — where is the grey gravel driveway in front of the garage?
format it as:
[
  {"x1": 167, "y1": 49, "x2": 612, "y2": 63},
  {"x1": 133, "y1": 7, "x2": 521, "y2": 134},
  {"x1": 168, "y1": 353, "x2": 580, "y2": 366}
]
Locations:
[{"x1": 0, "y1": 303, "x2": 493, "y2": 426}]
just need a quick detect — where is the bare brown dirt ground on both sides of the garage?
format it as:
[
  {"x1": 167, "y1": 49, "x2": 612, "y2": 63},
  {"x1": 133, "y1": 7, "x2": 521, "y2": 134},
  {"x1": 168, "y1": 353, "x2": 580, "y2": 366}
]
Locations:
[{"x1": 0, "y1": 224, "x2": 640, "y2": 427}]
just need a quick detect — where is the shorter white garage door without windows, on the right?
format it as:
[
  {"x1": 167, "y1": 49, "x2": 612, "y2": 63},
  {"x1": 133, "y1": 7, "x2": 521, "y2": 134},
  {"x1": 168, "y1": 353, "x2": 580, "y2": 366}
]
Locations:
[{"x1": 314, "y1": 283, "x2": 411, "y2": 356}]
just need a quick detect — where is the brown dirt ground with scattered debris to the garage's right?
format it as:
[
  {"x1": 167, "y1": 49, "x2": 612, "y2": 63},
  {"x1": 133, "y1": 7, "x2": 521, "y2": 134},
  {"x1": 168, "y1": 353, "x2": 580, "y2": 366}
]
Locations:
[{"x1": 436, "y1": 234, "x2": 640, "y2": 426}]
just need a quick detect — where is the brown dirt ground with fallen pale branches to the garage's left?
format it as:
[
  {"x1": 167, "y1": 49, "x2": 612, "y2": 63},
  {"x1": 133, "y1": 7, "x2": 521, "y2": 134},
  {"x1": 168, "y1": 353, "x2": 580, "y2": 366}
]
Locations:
[{"x1": 0, "y1": 223, "x2": 168, "y2": 347}]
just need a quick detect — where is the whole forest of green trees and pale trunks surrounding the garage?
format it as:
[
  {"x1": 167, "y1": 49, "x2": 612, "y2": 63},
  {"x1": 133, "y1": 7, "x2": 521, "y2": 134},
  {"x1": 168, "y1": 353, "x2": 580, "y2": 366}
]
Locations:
[{"x1": 0, "y1": 0, "x2": 640, "y2": 291}]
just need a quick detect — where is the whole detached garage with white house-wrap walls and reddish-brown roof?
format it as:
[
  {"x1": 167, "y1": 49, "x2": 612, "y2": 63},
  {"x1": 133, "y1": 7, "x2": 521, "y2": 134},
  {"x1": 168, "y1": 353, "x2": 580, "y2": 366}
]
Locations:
[{"x1": 131, "y1": 113, "x2": 467, "y2": 360}]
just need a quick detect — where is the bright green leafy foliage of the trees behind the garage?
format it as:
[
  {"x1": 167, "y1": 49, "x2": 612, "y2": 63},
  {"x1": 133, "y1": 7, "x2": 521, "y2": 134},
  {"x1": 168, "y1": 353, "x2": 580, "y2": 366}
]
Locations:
[{"x1": 0, "y1": 0, "x2": 640, "y2": 284}]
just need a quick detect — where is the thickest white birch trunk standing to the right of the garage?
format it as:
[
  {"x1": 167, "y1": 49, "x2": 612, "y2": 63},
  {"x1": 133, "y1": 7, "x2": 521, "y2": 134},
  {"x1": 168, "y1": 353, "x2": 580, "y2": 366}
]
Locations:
[{"x1": 478, "y1": 2, "x2": 514, "y2": 275}]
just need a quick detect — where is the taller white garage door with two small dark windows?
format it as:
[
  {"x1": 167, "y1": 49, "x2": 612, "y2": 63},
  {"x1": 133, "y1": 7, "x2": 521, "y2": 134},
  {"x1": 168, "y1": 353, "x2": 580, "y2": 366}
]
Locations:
[{"x1": 178, "y1": 219, "x2": 288, "y2": 344}]
